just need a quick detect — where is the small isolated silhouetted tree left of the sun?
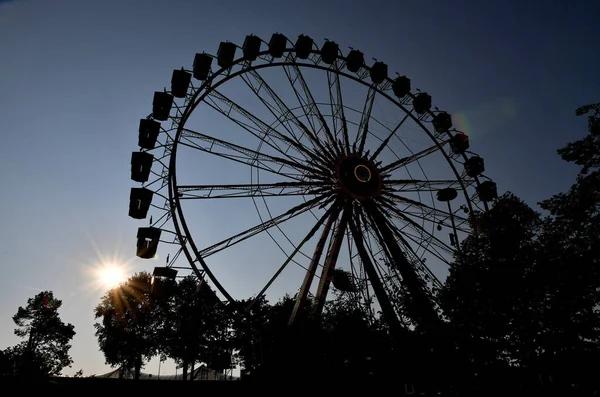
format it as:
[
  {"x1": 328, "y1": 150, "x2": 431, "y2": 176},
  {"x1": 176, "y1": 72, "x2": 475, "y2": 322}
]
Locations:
[{"x1": 3, "y1": 291, "x2": 75, "y2": 378}]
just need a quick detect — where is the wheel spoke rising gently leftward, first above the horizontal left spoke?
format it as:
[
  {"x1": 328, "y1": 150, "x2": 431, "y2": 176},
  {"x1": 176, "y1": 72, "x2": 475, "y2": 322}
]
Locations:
[{"x1": 181, "y1": 128, "x2": 320, "y2": 179}]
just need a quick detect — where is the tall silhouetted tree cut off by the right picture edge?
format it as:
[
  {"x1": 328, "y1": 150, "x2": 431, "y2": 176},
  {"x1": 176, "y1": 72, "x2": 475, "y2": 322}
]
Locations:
[{"x1": 537, "y1": 103, "x2": 600, "y2": 384}]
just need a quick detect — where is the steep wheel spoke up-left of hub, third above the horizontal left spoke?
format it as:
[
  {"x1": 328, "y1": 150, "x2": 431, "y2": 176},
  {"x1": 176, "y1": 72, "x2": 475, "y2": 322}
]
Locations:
[{"x1": 241, "y1": 70, "x2": 335, "y2": 160}]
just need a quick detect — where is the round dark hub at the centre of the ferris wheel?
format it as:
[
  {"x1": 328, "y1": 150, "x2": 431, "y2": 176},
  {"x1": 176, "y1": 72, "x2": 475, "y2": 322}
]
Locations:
[{"x1": 336, "y1": 155, "x2": 382, "y2": 200}]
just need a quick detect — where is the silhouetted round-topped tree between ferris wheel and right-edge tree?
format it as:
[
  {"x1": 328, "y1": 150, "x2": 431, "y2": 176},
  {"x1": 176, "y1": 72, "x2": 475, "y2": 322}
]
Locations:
[{"x1": 439, "y1": 193, "x2": 541, "y2": 365}]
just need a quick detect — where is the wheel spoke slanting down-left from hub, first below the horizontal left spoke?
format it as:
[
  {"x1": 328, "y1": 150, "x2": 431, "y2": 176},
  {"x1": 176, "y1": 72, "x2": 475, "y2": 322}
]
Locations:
[{"x1": 198, "y1": 194, "x2": 334, "y2": 258}]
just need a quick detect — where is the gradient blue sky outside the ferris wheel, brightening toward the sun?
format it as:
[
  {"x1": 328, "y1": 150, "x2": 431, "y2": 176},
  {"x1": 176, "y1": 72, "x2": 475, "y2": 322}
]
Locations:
[{"x1": 0, "y1": 0, "x2": 600, "y2": 375}]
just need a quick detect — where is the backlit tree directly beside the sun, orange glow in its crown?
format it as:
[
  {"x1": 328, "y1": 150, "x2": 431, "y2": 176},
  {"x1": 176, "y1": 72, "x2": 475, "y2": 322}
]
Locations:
[{"x1": 94, "y1": 272, "x2": 162, "y2": 379}]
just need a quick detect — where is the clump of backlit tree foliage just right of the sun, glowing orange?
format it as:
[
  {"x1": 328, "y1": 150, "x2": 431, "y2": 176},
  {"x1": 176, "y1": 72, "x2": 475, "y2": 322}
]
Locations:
[{"x1": 94, "y1": 272, "x2": 232, "y2": 380}]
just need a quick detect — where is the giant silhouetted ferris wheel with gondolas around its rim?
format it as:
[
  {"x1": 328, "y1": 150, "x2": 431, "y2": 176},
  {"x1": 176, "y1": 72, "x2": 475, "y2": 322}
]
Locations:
[{"x1": 129, "y1": 33, "x2": 497, "y2": 325}]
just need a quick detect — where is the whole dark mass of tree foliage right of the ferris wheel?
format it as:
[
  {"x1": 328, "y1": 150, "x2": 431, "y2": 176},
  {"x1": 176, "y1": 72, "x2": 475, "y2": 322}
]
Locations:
[{"x1": 439, "y1": 104, "x2": 600, "y2": 390}]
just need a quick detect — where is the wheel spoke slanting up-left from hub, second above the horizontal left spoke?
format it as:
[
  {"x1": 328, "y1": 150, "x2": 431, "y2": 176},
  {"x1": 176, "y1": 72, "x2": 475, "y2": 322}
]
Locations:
[{"x1": 208, "y1": 89, "x2": 326, "y2": 171}]
